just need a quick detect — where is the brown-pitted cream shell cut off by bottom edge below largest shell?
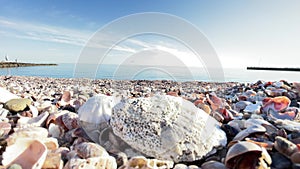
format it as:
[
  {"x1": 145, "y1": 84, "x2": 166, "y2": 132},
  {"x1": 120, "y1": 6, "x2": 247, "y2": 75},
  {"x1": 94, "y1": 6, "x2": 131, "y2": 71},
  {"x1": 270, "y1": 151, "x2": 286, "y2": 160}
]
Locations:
[{"x1": 120, "y1": 156, "x2": 174, "y2": 169}]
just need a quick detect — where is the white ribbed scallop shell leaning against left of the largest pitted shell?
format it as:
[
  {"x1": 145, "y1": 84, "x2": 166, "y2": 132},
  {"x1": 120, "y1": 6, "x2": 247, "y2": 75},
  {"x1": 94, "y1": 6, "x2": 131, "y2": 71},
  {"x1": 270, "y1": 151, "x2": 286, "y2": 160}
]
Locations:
[{"x1": 78, "y1": 94, "x2": 115, "y2": 124}]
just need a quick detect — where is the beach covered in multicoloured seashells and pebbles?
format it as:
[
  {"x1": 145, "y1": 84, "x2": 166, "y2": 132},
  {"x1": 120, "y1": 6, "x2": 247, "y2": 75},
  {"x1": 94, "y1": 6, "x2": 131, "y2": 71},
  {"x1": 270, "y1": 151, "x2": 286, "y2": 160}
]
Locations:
[{"x1": 0, "y1": 76, "x2": 300, "y2": 169}]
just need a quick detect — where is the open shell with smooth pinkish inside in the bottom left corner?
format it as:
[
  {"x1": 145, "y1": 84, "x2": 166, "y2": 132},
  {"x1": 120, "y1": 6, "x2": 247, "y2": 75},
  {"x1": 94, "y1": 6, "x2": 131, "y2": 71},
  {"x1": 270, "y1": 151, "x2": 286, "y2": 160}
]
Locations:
[{"x1": 2, "y1": 138, "x2": 47, "y2": 168}]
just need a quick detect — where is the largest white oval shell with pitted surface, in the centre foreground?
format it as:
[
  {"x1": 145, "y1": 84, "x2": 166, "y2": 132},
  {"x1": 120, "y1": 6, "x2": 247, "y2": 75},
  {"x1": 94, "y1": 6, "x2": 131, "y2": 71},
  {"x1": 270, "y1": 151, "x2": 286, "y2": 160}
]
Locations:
[{"x1": 110, "y1": 95, "x2": 227, "y2": 162}]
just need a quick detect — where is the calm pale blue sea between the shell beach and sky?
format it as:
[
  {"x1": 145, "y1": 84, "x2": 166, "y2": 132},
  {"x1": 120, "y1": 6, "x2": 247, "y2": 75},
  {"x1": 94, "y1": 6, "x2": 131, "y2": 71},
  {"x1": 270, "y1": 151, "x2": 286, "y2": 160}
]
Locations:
[{"x1": 0, "y1": 63, "x2": 300, "y2": 82}]
